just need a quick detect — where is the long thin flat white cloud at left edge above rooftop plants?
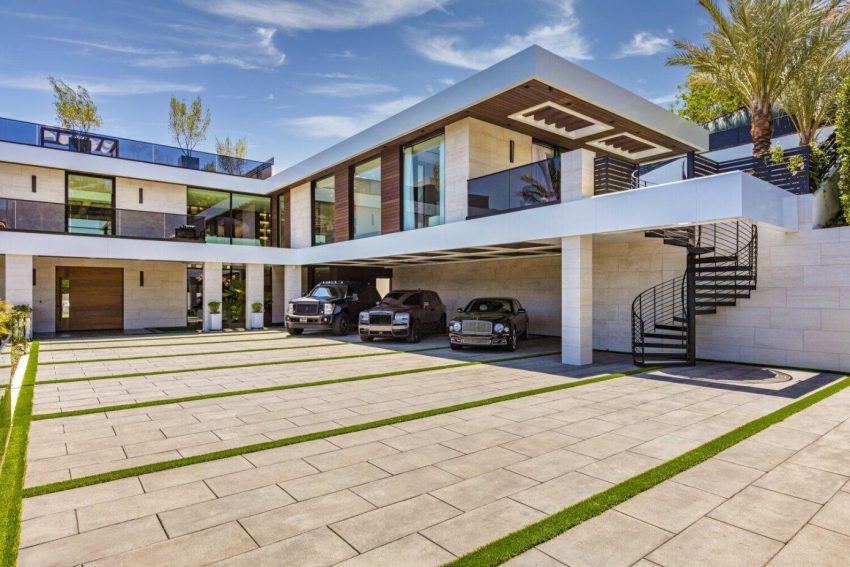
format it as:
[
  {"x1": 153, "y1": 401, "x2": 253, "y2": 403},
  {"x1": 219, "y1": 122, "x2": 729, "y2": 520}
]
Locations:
[{"x1": 0, "y1": 75, "x2": 204, "y2": 96}]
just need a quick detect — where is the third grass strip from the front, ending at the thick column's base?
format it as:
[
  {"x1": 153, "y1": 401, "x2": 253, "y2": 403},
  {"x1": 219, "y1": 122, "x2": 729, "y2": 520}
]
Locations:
[{"x1": 32, "y1": 352, "x2": 560, "y2": 421}]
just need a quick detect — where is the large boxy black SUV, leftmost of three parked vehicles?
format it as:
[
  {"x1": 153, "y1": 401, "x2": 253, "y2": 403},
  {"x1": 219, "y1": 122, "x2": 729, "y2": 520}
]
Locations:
[{"x1": 286, "y1": 281, "x2": 381, "y2": 335}]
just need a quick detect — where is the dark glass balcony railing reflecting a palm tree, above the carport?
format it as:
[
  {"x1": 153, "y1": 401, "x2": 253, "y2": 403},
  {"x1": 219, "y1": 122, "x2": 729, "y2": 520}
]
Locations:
[{"x1": 467, "y1": 157, "x2": 561, "y2": 218}]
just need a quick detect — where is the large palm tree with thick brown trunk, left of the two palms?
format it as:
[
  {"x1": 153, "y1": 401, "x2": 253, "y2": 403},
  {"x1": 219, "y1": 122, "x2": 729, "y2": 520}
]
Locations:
[{"x1": 667, "y1": 0, "x2": 847, "y2": 156}]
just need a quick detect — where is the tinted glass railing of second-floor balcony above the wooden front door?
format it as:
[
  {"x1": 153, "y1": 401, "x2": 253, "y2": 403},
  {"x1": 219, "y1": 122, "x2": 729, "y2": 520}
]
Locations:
[{"x1": 0, "y1": 199, "x2": 204, "y2": 242}]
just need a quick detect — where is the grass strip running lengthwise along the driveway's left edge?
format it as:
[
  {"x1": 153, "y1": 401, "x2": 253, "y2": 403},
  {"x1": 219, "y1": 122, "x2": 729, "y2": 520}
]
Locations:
[{"x1": 0, "y1": 341, "x2": 38, "y2": 565}]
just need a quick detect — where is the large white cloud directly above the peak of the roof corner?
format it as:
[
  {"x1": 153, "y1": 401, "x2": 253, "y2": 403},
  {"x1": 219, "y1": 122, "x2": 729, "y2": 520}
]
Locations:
[{"x1": 410, "y1": 0, "x2": 592, "y2": 71}]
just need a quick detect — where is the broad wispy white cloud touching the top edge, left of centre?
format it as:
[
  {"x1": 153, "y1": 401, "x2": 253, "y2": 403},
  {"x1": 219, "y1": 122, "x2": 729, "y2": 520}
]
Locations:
[{"x1": 187, "y1": 0, "x2": 450, "y2": 30}]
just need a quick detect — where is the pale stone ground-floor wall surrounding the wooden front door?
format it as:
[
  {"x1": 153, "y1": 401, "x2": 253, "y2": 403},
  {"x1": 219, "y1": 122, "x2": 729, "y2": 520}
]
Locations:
[{"x1": 33, "y1": 257, "x2": 186, "y2": 333}]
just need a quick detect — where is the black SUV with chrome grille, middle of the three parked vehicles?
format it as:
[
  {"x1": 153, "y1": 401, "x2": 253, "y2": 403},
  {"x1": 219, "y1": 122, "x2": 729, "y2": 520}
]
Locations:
[{"x1": 359, "y1": 289, "x2": 446, "y2": 343}]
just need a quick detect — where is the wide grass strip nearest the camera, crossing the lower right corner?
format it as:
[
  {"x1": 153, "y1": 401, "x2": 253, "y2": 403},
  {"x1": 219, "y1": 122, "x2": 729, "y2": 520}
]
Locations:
[{"x1": 445, "y1": 376, "x2": 850, "y2": 567}]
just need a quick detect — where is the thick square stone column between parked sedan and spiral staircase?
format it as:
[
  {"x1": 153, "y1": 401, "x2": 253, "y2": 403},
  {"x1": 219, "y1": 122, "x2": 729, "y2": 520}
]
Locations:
[{"x1": 561, "y1": 235, "x2": 593, "y2": 365}]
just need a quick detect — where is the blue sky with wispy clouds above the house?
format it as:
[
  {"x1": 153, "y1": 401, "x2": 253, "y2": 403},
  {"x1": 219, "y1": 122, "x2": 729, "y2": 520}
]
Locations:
[{"x1": 0, "y1": 0, "x2": 707, "y2": 166}]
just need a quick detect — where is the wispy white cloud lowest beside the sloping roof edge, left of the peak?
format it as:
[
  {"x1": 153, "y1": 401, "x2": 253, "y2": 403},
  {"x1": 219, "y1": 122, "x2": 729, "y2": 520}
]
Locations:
[{"x1": 284, "y1": 96, "x2": 422, "y2": 139}]
